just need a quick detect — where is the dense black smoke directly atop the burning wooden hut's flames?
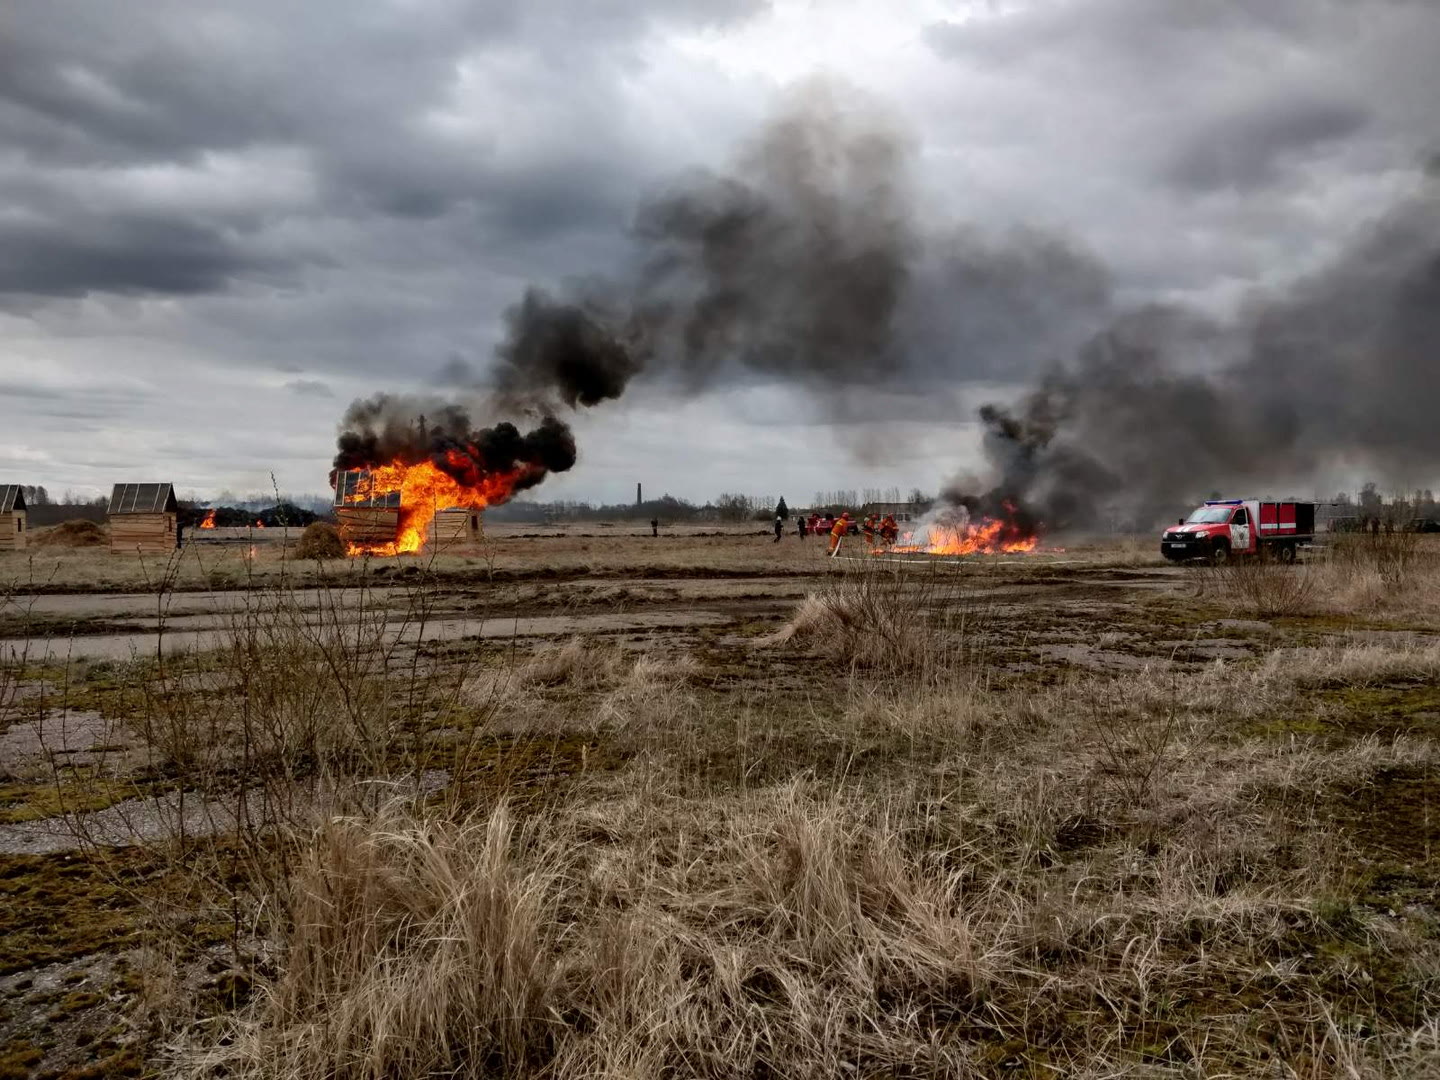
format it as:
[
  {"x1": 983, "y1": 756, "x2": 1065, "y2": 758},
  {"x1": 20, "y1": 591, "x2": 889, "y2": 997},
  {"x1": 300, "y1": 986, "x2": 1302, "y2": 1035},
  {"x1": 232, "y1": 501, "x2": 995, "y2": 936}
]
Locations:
[{"x1": 331, "y1": 393, "x2": 575, "y2": 491}]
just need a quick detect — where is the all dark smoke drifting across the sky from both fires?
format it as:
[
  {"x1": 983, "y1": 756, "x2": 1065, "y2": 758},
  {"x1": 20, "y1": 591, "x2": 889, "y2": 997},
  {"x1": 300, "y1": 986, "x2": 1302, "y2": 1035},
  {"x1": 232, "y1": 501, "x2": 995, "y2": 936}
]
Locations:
[{"x1": 345, "y1": 86, "x2": 1440, "y2": 528}]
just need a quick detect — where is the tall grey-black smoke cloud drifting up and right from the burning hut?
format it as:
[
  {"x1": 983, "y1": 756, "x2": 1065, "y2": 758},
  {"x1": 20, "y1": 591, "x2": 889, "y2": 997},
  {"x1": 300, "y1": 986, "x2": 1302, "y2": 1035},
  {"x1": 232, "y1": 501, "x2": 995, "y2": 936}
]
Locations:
[{"x1": 472, "y1": 84, "x2": 1109, "y2": 419}]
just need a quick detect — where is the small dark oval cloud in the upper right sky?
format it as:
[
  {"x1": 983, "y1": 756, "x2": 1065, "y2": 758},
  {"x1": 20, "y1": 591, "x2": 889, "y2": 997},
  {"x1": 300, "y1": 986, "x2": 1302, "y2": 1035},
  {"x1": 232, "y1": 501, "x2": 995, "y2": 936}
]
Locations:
[{"x1": 1165, "y1": 101, "x2": 1369, "y2": 192}]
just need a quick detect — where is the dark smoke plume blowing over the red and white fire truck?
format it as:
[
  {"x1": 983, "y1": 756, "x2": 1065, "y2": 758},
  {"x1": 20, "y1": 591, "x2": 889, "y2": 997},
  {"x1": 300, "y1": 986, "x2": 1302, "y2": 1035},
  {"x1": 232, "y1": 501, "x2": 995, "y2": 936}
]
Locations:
[{"x1": 961, "y1": 179, "x2": 1440, "y2": 528}]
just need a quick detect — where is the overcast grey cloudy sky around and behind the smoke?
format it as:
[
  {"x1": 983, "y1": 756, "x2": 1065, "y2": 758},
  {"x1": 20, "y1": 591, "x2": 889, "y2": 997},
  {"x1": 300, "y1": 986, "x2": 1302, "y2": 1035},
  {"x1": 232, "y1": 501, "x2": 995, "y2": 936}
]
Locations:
[{"x1": 0, "y1": 0, "x2": 1440, "y2": 501}]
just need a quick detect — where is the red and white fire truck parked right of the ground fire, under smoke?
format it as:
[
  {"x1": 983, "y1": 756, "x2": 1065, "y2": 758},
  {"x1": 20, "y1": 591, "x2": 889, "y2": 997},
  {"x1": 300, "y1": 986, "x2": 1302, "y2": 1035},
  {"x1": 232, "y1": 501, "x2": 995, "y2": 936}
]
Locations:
[{"x1": 1161, "y1": 498, "x2": 1315, "y2": 563}]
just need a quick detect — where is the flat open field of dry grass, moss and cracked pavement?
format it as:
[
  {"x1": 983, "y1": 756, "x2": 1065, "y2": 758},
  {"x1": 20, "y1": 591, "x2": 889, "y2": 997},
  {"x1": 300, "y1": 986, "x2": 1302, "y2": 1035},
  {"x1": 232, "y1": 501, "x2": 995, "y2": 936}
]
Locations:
[{"x1": 0, "y1": 524, "x2": 1440, "y2": 1079}]
